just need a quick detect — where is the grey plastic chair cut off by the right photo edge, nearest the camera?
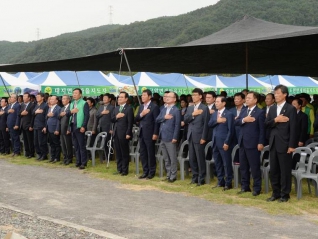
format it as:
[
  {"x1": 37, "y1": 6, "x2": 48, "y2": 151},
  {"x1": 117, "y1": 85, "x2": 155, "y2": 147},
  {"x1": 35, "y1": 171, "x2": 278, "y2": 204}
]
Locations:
[{"x1": 296, "y1": 151, "x2": 318, "y2": 199}]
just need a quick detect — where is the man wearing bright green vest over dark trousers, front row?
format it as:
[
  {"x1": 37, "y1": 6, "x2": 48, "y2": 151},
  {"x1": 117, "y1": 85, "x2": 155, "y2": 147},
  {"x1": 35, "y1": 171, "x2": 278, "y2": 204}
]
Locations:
[{"x1": 69, "y1": 88, "x2": 89, "y2": 169}]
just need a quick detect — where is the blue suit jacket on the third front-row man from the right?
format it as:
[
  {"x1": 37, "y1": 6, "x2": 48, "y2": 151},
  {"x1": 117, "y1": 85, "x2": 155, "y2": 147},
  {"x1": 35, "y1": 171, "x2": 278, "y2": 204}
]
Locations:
[{"x1": 209, "y1": 109, "x2": 234, "y2": 148}]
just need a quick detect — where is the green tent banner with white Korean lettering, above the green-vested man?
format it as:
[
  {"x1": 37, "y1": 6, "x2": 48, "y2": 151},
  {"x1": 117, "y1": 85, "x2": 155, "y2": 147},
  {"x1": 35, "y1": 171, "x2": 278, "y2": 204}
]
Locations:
[{"x1": 41, "y1": 86, "x2": 118, "y2": 96}]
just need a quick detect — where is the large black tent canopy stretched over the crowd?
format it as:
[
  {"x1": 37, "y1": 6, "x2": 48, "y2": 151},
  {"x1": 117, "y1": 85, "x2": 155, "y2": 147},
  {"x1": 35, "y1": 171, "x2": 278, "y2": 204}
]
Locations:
[{"x1": 0, "y1": 16, "x2": 318, "y2": 76}]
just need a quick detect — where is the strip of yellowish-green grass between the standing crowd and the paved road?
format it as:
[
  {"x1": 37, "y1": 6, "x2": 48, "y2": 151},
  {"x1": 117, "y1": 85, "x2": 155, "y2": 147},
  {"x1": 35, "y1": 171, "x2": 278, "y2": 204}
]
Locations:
[{"x1": 3, "y1": 156, "x2": 318, "y2": 218}]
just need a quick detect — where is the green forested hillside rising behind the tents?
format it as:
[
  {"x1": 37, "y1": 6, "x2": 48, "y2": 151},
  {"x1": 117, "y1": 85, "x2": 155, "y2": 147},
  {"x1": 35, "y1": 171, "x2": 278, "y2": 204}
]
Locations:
[{"x1": 0, "y1": 0, "x2": 318, "y2": 63}]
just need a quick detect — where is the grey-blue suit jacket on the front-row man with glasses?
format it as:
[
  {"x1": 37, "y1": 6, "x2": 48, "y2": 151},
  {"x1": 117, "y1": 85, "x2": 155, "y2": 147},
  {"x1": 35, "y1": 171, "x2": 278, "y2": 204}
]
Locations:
[{"x1": 156, "y1": 105, "x2": 181, "y2": 142}]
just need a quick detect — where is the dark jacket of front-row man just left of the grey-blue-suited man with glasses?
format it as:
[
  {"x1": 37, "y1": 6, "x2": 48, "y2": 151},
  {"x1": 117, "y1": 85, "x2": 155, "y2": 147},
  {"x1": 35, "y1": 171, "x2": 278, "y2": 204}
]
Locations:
[{"x1": 135, "y1": 102, "x2": 159, "y2": 139}]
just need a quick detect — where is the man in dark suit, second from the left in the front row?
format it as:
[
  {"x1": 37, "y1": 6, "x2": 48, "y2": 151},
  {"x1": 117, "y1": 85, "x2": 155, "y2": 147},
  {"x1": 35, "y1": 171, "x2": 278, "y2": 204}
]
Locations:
[{"x1": 7, "y1": 94, "x2": 21, "y2": 157}]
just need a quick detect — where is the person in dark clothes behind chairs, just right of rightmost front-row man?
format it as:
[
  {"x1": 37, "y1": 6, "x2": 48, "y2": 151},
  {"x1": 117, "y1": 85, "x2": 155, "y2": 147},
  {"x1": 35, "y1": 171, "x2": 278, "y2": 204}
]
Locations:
[{"x1": 292, "y1": 98, "x2": 308, "y2": 169}]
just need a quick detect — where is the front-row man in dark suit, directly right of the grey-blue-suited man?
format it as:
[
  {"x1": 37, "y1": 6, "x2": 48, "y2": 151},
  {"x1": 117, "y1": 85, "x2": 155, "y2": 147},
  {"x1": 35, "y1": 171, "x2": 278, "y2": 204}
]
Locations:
[{"x1": 184, "y1": 88, "x2": 210, "y2": 186}]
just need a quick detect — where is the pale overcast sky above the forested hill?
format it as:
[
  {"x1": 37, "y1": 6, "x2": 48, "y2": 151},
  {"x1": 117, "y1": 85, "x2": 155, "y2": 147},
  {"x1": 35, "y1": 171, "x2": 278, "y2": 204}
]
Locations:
[{"x1": 0, "y1": 0, "x2": 218, "y2": 42}]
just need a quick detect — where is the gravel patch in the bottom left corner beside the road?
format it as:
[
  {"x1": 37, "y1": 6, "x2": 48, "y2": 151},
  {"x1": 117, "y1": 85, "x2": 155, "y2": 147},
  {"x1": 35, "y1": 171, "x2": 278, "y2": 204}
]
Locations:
[{"x1": 0, "y1": 207, "x2": 106, "y2": 239}]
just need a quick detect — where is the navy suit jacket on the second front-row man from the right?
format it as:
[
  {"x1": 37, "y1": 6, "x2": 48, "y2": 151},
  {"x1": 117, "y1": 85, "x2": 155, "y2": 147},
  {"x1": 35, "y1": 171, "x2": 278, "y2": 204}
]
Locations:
[{"x1": 235, "y1": 106, "x2": 265, "y2": 149}]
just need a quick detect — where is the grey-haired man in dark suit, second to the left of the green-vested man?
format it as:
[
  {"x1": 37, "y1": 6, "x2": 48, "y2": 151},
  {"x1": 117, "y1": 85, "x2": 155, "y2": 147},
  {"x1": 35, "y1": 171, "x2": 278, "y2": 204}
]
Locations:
[{"x1": 46, "y1": 95, "x2": 61, "y2": 163}]
